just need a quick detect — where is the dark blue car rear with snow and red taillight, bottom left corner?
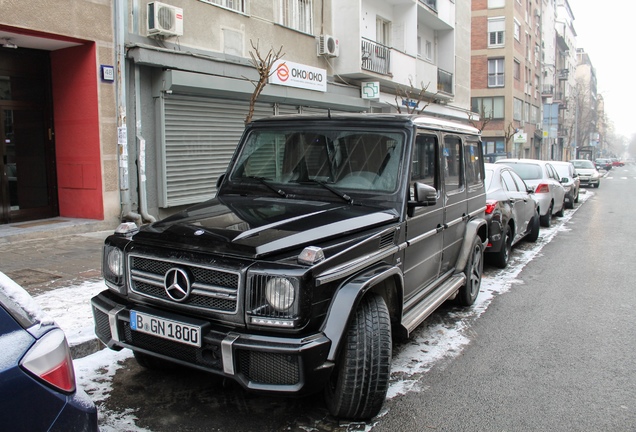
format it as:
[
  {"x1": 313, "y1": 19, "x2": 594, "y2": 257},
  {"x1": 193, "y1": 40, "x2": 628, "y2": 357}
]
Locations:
[{"x1": 0, "y1": 272, "x2": 98, "y2": 431}]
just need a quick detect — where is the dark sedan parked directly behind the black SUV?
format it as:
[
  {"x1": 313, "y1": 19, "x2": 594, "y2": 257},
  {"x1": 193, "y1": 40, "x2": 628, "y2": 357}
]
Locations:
[{"x1": 485, "y1": 163, "x2": 540, "y2": 268}]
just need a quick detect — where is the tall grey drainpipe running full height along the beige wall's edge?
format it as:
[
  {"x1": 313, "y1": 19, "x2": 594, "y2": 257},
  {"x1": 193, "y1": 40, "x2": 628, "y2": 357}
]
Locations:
[{"x1": 115, "y1": 0, "x2": 143, "y2": 225}]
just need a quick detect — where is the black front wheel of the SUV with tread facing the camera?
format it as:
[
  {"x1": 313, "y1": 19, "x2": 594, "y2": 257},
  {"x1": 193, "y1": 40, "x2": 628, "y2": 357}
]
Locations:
[{"x1": 325, "y1": 294, "x2": 392, "y2": 421}]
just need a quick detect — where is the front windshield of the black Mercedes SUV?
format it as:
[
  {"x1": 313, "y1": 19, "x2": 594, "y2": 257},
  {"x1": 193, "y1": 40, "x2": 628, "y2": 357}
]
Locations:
[{"x1": 230, "y1": 129, "x2": 406, "y2": 192}]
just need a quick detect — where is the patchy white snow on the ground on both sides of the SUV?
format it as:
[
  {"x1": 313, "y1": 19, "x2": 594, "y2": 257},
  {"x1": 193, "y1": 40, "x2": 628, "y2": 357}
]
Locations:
[{"x1": 28, "y1": 190, "x2": 594, "y2": 432}]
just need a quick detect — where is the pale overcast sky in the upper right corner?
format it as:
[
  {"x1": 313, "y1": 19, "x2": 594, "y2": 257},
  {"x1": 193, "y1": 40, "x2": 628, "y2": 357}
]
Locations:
[{"x1": 569, "y1": 0, "x2": 636, "y2": 138}]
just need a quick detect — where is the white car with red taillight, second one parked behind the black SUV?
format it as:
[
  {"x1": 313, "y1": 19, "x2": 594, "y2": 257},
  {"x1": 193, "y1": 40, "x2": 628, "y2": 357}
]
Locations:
[{"x1": 495, "y1": 159, "x2": 565, "y2": 227}]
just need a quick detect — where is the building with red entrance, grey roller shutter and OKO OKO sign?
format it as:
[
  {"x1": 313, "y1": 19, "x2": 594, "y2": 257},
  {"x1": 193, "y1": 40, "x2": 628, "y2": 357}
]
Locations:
[{"x1": 0, "y1": 0, "x2": 470, "y2": 223}]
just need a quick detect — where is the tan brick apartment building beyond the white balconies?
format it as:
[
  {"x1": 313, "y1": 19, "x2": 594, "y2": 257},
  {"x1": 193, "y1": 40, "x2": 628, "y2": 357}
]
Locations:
[{"x1": 471, "y1": 0, "x2": 547, "y2": 159}]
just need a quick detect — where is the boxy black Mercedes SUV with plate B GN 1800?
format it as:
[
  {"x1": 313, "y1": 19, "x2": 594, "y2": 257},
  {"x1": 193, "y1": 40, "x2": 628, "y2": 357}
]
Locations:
[{"x1": 92, "y1": 114, "x2": 487, "y2": 420}]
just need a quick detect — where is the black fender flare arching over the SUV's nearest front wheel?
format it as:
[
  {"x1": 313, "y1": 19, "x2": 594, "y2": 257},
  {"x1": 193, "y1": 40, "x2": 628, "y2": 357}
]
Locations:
[{"x1": 321, "y1": 265, "x2": 404, "y2": 362}]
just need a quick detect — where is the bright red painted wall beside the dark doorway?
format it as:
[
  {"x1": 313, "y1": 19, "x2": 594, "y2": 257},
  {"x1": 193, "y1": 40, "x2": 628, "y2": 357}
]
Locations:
[{"x1": 51, "y1": 43, "x2": 104, "y2": 220}]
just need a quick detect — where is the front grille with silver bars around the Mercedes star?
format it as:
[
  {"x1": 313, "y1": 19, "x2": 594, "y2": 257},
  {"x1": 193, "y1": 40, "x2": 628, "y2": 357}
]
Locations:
[{"x1": 128, "y1": 255, "x2": 240, "y2": 313}]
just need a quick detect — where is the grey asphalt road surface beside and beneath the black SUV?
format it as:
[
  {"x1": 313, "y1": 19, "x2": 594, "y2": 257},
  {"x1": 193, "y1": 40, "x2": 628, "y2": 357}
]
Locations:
[{"x1": 99, "y1": 166, "x2": 636, "y2": 432}]
